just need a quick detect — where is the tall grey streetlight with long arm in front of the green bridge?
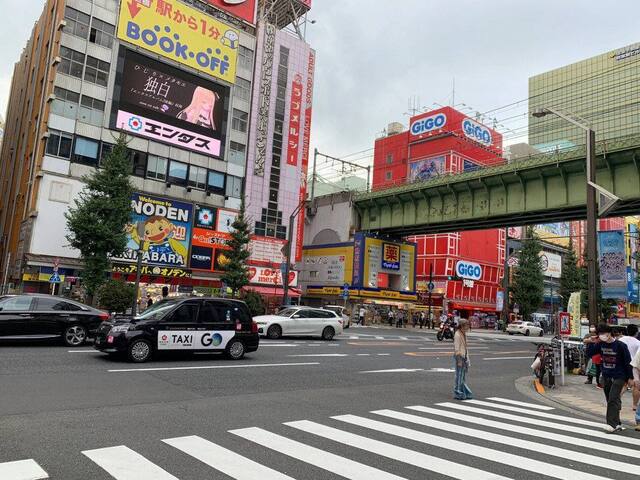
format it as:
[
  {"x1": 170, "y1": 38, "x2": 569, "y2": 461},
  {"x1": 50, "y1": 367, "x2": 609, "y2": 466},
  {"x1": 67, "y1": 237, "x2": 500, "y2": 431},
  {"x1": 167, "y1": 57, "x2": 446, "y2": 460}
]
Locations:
[{"x1": 532, "y1": 107, "x2": 619, "y2": 325}]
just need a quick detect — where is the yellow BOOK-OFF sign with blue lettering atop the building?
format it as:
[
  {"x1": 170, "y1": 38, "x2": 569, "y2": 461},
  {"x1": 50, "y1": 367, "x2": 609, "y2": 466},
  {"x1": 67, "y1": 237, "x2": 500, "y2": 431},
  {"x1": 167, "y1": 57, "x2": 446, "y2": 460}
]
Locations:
[{"x1": 118, "y1": 0, "x2": 240, "y2": 83}]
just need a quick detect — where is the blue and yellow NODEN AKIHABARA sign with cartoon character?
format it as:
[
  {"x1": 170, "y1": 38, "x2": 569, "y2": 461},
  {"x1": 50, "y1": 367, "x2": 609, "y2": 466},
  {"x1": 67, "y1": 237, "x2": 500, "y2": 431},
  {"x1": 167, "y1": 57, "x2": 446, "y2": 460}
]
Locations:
[{"x1": 116, "y1": 193, "x2": 193, "y2": 267}]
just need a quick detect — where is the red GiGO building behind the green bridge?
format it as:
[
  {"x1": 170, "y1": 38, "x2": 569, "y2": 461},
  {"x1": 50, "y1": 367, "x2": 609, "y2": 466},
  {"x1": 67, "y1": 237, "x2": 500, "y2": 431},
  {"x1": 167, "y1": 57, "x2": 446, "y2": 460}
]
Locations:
[{"x1": 372, "y1": 107, "x2": 506, "y2": 318}]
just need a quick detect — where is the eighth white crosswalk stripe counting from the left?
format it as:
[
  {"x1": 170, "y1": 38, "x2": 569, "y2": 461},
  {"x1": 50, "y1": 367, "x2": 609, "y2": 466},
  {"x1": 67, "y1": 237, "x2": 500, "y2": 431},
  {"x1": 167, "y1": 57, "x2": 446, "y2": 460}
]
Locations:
[{"x1": 408, "y1": 405, "x2": 638, "y2": 458}]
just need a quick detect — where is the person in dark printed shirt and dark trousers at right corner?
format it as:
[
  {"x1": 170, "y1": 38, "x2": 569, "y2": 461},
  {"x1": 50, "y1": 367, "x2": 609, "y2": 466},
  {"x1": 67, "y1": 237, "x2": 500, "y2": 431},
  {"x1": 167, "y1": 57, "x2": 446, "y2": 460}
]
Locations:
[{"x1": 584, "y1": 323, "x2": 633, "y2": 433}]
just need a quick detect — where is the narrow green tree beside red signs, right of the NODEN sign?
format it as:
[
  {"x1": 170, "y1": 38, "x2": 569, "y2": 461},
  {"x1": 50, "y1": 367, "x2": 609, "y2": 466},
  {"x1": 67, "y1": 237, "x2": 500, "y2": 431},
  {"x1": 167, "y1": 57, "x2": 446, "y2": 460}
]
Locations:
[{"x1": 221, "y1": 200, "x2": 251, "y2": 297}]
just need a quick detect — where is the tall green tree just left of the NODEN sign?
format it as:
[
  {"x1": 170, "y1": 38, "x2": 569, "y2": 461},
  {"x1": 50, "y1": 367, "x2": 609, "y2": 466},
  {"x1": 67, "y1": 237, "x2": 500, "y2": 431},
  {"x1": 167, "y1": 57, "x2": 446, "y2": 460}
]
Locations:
[{"x1": 65, "y1": 134, "x2": 133, "y2": 299}]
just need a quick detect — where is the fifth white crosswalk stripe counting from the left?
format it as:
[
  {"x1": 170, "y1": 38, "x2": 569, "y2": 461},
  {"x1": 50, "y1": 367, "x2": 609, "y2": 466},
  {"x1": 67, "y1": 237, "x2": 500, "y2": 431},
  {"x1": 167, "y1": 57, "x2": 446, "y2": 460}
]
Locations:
[{"x1": 285, "y1": 420, "x2": 506, "y2": 480}]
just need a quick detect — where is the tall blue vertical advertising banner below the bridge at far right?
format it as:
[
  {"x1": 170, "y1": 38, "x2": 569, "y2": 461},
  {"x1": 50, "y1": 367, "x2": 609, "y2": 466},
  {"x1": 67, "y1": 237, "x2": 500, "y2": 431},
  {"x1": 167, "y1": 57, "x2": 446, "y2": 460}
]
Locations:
[{"x1": 598, "y1": 230, "x2": 627, "y2": 299}]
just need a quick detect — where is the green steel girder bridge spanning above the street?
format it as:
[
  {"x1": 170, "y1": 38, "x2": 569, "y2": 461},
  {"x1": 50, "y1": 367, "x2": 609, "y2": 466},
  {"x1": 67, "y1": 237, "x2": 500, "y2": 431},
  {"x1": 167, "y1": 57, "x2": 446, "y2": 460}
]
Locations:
[{"x1": 354, "y1": 135, "x2": 640, "y2": 236}]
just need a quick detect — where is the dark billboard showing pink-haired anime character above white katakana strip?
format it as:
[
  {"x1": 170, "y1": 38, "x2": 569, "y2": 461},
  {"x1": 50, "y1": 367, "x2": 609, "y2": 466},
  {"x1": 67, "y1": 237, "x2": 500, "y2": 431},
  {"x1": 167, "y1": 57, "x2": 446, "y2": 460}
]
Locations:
[{"x1": 111, "y1": 48, "x2": 229, "y2": 157}]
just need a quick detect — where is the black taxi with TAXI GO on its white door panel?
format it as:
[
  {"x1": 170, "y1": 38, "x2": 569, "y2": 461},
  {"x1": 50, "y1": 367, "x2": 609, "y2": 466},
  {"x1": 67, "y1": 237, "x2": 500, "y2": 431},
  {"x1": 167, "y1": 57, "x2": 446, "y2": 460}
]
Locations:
[{"x1": 94, "y1": 297, "x2": 259, "y2": 362}]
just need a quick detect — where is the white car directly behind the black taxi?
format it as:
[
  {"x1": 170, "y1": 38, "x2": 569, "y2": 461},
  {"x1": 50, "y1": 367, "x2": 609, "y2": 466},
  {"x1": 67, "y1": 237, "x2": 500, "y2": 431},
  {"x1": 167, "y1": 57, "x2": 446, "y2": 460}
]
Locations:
[{"x1": 253, "y1": 307, "x2": 344, "y2": 340}]
